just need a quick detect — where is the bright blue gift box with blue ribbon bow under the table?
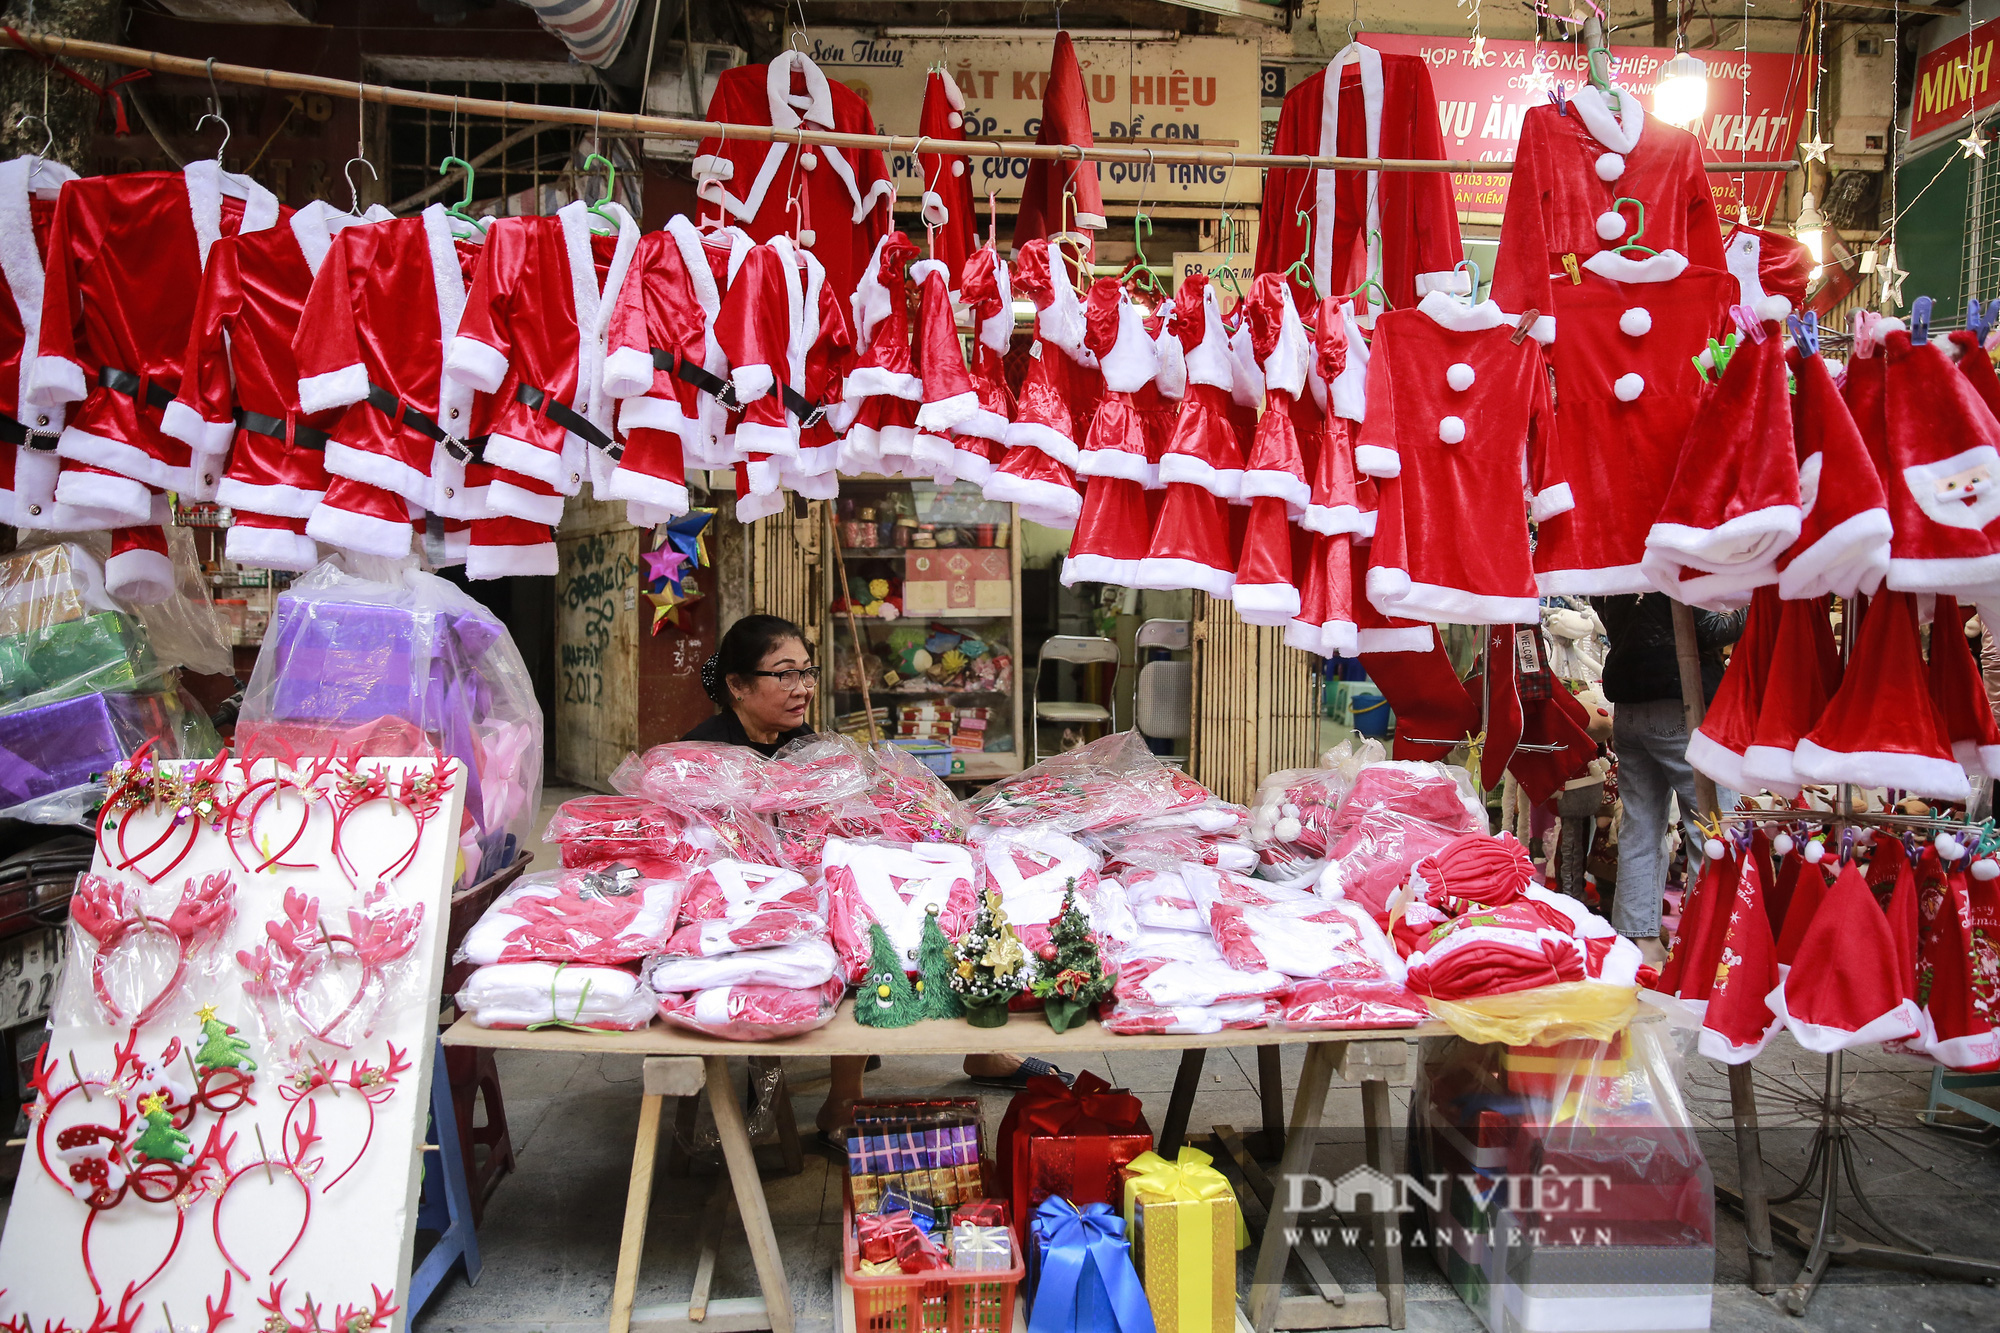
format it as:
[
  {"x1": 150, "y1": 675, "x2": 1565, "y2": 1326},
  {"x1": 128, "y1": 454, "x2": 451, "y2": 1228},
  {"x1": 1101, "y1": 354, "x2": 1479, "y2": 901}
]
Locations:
[{"x1": 1028, "y1": 1197, "x2": 1154, "y2": 1333}]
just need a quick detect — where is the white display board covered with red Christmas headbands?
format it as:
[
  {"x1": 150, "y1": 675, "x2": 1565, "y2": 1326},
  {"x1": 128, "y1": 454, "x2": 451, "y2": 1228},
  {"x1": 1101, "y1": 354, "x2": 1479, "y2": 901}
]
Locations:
[{"x1": 0, "y1": 759, "x2": 464, "y2": 1333}]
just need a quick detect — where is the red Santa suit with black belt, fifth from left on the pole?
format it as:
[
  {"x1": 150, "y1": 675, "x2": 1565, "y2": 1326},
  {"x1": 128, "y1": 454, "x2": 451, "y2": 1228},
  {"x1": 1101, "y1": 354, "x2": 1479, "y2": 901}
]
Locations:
[{"x1": 444, "y1": 200, "x2": 638, "y2": 526}]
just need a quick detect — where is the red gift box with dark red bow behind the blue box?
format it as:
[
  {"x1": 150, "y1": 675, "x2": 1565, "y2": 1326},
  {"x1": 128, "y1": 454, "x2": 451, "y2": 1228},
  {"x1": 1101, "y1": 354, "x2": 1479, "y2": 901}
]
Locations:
[{"x1": 1000, "y1": 1069, "x2": 1152, "y2": 1231}]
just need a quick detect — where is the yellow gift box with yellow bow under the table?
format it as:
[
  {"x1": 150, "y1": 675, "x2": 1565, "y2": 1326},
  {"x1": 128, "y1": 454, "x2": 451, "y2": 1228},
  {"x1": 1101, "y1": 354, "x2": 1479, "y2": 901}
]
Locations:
[{"x1": 1122, "y1": 1147, "x2": 1250, "y2": 1333}]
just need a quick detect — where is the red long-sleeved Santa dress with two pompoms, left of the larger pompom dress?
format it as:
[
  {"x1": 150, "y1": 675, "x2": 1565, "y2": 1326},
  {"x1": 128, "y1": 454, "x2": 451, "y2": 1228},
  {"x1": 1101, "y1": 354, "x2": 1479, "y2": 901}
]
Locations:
[{"x1": 1354, "y1": 292, "x2": 1574, "y2": 624}]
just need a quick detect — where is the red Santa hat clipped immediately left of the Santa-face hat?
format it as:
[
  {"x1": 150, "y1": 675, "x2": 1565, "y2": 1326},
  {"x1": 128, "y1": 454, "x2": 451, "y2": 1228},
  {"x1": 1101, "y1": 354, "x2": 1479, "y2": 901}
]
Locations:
[{"x1": 1778, "y1": 348, "x2": 1890, "y2": 600}]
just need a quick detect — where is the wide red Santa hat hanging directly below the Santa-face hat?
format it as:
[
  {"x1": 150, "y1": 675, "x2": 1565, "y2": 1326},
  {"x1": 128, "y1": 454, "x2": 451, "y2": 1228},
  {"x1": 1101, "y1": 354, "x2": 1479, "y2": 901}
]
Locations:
[{"x1": 1792, "y1": 592, "x2": 1970, "y2": 801}]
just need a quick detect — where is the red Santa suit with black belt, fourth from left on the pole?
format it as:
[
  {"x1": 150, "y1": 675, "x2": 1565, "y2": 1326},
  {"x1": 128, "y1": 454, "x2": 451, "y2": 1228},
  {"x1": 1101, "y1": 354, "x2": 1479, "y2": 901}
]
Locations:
[{"x1": 292, "y1": 204, "x2": 486, "y2": 554}]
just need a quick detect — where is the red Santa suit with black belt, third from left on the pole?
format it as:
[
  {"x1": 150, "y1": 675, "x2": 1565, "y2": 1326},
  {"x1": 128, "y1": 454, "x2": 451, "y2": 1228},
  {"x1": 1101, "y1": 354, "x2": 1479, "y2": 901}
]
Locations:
[{"x1": 160, "y1": 200, "x2": 390, "y2": 572}]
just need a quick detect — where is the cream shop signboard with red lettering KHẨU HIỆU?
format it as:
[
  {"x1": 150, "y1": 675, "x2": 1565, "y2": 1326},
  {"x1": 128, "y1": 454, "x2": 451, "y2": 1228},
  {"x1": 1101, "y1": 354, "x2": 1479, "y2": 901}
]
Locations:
[{"x1": 800, "y1": 28, "x2": 1262, "y2": 206}]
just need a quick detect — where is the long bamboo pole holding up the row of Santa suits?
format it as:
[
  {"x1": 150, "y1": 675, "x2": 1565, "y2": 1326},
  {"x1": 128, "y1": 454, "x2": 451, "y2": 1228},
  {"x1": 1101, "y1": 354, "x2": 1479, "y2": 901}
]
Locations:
[{"x1": 0, "y1": 32, "x2": 1800, "y2": 176}]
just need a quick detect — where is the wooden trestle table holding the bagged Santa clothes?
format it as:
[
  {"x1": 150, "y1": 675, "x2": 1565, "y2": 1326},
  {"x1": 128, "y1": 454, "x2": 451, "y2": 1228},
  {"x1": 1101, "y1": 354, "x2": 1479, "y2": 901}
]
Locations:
[{"x1": 444, "y1": 1001, "x2": 1448, "y2": 1333}]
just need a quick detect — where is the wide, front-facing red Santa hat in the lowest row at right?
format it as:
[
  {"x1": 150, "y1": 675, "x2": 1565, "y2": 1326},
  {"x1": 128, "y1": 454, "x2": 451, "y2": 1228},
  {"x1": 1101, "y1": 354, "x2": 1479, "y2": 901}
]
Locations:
[{"x1": 1766, "y1": 863, "x2": 1918, "y2": 1055}]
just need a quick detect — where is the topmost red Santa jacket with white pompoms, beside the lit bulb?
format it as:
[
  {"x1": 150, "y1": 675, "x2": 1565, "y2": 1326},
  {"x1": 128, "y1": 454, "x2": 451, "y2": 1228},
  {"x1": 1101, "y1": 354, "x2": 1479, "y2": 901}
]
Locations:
[{"x1": 1492, "y1": 88, "x2": 1724, "y2": 332}]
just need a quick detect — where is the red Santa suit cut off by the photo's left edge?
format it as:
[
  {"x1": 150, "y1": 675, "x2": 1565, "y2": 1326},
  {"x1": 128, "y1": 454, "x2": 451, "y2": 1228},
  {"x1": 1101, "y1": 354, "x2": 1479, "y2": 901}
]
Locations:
[{"x1": 0, "y1": 156, "x2": 76, "y2": 528}]
